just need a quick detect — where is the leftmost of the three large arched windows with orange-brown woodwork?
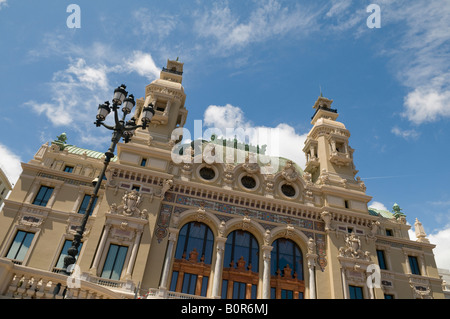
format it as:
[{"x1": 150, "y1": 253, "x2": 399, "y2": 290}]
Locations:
[{"x1": 170, "y1": 222, "x2": 214, "y2": 297}]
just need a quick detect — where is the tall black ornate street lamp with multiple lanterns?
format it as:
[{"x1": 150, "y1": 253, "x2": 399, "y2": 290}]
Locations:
[{"x1": 63, "y1": 84, "x2": 155, "y2": 275}]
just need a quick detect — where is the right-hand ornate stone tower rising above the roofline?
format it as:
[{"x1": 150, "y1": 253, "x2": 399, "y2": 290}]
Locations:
[{"x1": 303, "y1": 96, "x2": 358, "y2": 182}]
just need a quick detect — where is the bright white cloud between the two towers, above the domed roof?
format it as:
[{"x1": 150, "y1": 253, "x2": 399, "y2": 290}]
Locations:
[{"x1": 203, "y1": 104, "x2": 307, "y2": 167}]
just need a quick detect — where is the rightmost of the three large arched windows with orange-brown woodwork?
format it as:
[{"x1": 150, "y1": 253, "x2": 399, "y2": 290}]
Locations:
[{"x1": 270, "y1": 238, "x2": 305, "y2": 299}]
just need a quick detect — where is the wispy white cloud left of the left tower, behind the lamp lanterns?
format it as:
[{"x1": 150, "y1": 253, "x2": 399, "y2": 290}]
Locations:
[{"x1": 24, "y1": 50, "x2": 160, "y2": 130}]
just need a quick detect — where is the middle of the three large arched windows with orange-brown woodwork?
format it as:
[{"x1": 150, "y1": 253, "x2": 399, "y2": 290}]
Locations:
[{"x1": 222, "y1": 230, "x2": 259, "y2": 299}]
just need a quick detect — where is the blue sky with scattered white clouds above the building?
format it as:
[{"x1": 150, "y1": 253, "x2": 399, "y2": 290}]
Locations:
[{"x1": 0, "y1": 0, "x2": 450, "y2": 269}]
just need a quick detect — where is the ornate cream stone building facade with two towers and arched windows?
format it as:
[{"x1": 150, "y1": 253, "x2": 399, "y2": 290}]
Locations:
[{"x1": 0, "y1": 60, "x2": 444, "y2": 299}]
